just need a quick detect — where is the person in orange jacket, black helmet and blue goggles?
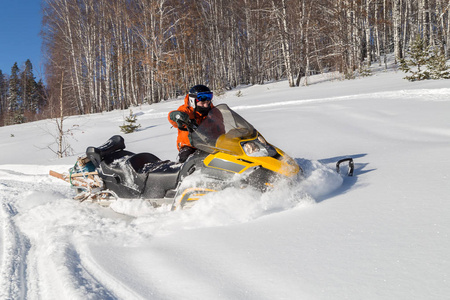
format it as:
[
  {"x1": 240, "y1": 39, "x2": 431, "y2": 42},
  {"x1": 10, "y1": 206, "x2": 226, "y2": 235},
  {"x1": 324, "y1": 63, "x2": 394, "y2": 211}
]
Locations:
[{"x1": 168, "y1": 84, "x2": 214, "y2": 163}]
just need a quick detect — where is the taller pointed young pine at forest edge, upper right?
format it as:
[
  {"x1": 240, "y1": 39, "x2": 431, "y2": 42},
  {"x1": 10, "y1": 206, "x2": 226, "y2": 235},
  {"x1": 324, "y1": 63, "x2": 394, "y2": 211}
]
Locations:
[{"x1": 400, "y1": 36, "x2": 430, "y2": 81}]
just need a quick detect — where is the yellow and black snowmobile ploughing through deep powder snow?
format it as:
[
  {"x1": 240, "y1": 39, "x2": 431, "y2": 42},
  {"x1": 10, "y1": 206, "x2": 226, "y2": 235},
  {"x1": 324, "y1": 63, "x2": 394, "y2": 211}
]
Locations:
[{"x1": 50, "y1": 104, "x2": 353, "y2": 210}]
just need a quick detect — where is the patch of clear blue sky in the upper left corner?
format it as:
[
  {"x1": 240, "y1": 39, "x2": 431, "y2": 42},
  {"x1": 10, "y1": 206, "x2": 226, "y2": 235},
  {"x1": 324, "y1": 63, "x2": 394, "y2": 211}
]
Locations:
[{"x1": 0, "y1": 0, "x2": 43, "y2": 79}]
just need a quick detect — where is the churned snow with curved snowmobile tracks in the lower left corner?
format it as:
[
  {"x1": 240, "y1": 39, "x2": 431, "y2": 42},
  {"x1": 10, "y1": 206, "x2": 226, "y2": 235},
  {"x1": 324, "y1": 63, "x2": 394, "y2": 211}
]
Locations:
[{"x1": 0, "y1": 169, "x2": 125, "y2": 299}]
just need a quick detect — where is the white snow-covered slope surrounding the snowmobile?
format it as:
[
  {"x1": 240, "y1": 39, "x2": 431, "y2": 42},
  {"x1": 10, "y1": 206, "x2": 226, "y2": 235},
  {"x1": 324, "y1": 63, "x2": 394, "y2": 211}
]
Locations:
[{"x1": 0, "y1": 66, "x2": 450, "y2": 300}]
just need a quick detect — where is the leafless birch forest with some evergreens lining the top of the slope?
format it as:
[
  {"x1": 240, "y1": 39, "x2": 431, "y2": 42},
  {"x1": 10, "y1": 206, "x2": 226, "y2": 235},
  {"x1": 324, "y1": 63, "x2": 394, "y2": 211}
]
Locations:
[{"x1": 0, "y1": 0, "x2": 450, "y2": 125}]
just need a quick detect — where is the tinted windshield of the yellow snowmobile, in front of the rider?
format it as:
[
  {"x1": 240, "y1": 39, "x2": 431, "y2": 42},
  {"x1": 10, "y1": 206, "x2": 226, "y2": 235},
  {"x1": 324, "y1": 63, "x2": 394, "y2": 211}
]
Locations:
[{"x1": 189, "y1": 104, "x2": 257, "y2": 153}]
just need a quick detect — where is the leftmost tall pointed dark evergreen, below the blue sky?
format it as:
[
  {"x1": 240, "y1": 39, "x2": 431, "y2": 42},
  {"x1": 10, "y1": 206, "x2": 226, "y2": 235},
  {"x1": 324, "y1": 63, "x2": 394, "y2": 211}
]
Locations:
[{"x1": 7, "y1": 62, "x2": 24, "y2": 124}]
